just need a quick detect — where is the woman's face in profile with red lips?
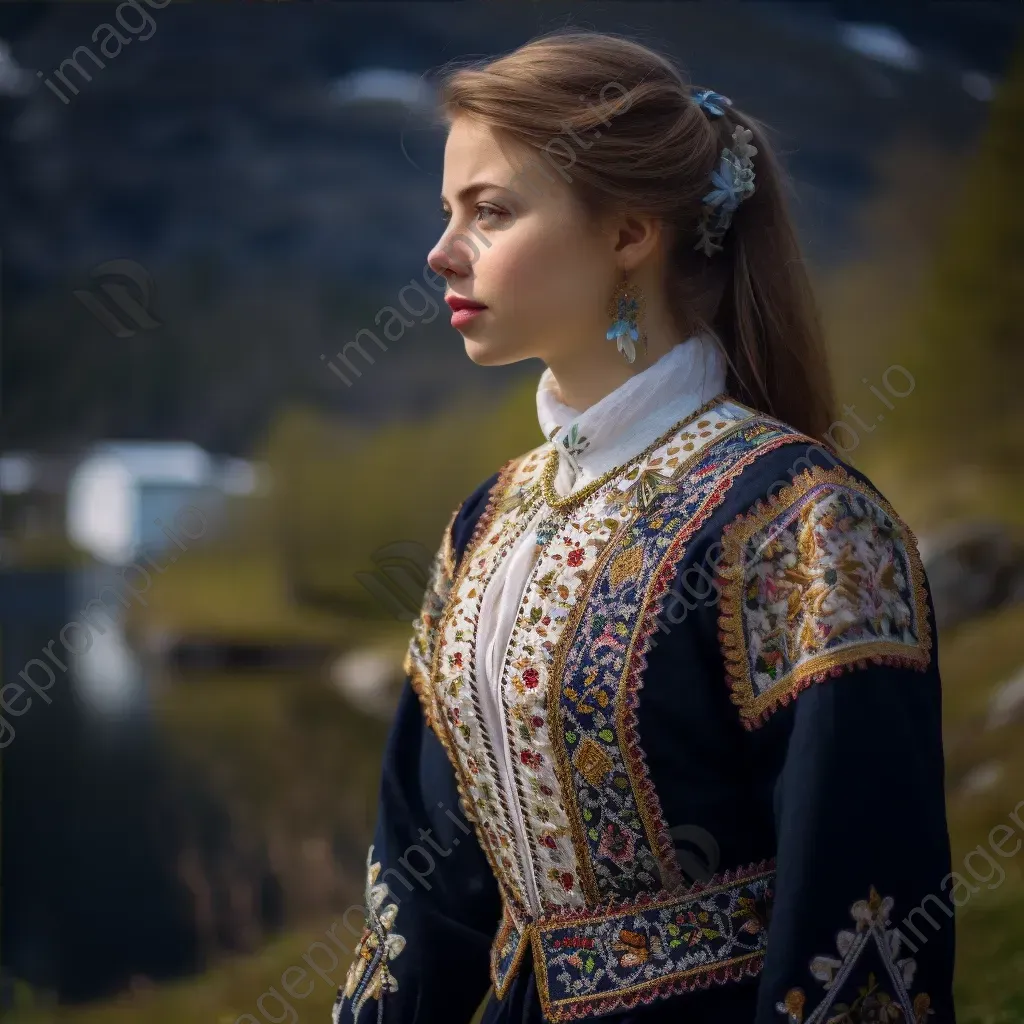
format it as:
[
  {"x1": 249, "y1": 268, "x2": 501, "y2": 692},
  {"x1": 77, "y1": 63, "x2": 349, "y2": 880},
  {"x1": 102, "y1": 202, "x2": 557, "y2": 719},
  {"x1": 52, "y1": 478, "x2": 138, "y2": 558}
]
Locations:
[{"x1": 427, "y1": 117, "x2": 617, "y2": 366}]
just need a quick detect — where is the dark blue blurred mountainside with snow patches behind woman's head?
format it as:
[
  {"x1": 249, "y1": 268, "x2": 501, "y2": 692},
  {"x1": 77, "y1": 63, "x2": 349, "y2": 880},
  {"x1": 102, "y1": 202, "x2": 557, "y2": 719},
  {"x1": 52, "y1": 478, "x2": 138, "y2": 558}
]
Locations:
[{"x1": 0, "y1": 2, "x2": 1021, "y2": 453}]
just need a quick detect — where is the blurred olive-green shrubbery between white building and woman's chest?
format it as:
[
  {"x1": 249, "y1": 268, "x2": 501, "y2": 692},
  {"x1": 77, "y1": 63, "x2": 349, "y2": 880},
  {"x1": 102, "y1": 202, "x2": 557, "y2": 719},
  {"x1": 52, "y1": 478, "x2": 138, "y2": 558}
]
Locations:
[{"x1": 264, "y1": 379, "x2": 544, "y2": 614}]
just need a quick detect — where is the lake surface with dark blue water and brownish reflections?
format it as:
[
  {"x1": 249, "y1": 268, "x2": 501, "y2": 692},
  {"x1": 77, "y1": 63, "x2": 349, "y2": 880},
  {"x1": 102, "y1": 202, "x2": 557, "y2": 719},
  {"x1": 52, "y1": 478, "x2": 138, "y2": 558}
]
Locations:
[{"x1": 0, "y1": 568, "x2": 364, "y2": 1001}]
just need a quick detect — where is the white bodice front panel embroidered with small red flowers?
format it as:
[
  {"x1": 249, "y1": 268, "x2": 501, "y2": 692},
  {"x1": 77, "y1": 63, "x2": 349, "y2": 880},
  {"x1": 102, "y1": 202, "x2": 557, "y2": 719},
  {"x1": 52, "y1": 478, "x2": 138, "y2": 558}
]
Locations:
[{"x1": 433, "y1": 402, "x2": 751, "y2": 913}]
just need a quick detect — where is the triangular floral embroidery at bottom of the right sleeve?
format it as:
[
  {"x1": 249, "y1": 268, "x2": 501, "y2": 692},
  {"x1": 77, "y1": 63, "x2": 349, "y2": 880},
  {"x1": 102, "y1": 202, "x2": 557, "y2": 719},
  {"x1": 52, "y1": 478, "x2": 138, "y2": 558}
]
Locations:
[{"x1": 775, "y1": 886, "x2": 935, "y2": 1024}]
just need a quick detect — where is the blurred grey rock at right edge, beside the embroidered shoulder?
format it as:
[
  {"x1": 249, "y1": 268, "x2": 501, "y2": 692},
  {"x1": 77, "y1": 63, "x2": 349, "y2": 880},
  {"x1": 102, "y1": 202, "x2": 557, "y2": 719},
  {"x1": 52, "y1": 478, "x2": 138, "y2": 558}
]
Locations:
[{"x1": 920, "y1": 522, "x2": 1024, "y2": 629}]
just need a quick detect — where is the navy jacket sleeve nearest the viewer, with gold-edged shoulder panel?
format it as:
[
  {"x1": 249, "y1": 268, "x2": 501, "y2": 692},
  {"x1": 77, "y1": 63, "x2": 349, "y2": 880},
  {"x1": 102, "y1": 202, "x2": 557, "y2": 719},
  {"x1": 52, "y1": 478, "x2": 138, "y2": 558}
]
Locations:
[{"x1": 719, "y1": 466, "x2": 956, "y2": 1024}]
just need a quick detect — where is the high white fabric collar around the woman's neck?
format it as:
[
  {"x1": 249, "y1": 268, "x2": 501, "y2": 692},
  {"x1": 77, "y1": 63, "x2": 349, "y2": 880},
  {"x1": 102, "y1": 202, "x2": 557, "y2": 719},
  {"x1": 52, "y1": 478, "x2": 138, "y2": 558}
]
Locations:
[{"x1": 537, "y1": 334, "x2": 726, "y2": 496}]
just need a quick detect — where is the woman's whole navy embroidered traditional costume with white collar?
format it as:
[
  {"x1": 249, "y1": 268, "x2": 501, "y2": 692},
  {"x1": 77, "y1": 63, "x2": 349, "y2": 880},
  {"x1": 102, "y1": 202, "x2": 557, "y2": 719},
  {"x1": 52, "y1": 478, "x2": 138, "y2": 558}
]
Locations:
[{"x1": 334, "y1": 335, "x2": 954, "y2": 1024}]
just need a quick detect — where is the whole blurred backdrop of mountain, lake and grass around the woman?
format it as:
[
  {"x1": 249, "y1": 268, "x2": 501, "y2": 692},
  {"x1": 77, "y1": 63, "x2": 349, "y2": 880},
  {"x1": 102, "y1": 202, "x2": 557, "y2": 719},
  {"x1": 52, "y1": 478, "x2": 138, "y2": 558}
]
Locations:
[{"x1": 0, "y1": 0, "x2": 1024, "y2": 1024}]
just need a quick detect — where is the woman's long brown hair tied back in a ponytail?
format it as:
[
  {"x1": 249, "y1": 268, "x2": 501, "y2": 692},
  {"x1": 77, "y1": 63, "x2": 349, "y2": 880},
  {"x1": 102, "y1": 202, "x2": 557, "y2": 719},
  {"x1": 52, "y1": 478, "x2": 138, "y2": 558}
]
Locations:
[{"x1": 440, "y1": 30, "x2": 833, "y2": 437}]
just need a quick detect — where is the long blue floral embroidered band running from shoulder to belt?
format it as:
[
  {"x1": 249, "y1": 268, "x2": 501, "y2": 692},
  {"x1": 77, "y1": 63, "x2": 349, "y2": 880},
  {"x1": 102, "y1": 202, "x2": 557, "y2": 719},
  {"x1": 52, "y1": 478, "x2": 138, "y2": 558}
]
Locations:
[{"x1": 553, "y1": 410, "x2": 800, "y2": 900}]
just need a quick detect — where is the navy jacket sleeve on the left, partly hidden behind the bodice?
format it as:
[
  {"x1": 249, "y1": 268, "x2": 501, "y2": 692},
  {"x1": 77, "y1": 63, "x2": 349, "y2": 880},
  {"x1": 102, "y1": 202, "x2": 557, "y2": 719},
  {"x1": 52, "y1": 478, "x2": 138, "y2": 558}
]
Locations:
[{"x1": 333, "y1": 479, "x2": 501, "y2": 1024}]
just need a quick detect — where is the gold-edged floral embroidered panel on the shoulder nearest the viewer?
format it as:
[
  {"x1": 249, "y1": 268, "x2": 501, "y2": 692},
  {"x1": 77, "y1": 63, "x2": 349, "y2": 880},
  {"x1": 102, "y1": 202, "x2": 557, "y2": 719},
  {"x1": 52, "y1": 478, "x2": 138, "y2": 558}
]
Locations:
[{"x1": 718, "y1": 466, "x2": 932, "y2": 729}]
